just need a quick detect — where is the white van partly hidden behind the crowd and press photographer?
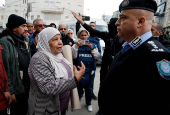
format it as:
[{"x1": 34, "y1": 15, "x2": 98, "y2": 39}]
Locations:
[{"x1": 59, "y1": 18, "x2": 108, "y2": 64}]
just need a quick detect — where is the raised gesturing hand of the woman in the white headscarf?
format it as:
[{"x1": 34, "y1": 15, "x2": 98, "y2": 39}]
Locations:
[{"x1": 73, "y1": 61, "x2": 86, "y2": 81}]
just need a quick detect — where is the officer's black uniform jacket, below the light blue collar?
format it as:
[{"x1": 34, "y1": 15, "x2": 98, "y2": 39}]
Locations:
[{"x1": 98, "y1": 37, "x2": 170, "y2": 115}]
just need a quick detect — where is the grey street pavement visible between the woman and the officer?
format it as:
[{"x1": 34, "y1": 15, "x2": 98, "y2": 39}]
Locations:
[{"x1": 67, "y1": 65, "x2": 100, "y2": 115}]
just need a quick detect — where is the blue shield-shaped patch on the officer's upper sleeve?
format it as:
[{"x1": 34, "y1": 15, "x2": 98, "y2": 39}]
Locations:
[{"x1": 156, "y1": 59, "x2": 170, "y2": 80}]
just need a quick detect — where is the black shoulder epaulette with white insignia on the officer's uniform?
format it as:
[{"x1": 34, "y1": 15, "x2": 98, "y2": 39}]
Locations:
[{"x1": 144, "y1": 40, "x2": 166, "y2": 52}]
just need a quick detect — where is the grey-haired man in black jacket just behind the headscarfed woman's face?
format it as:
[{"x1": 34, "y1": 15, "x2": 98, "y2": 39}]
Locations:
[{"x1": 58, "y1": 24, "x2": 74, "y2": 46}]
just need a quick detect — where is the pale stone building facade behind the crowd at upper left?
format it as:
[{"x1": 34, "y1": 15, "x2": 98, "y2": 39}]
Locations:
[{"x1": 0, "y1": 0, "x2": 84, "y2": 30}]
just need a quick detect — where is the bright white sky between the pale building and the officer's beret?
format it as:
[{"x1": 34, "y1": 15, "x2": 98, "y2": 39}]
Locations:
[{"x1": 0, "y1": 0, "x2": 122, "y2": 18}]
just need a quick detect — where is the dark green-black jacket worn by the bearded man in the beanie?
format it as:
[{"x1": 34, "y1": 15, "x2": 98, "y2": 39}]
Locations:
[{"x1": 0, "y1": 30, "x2": 31, "y2": 94}]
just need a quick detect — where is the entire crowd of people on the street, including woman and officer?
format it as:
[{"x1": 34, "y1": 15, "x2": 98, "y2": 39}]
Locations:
[{"x1": 0, "y1": 0, "x2": 170, "y2": 115}]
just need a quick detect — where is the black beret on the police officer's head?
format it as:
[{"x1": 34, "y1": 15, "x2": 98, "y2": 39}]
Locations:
[{"x1": 119, "y1": 0, "x2": 157, "y2": 13}]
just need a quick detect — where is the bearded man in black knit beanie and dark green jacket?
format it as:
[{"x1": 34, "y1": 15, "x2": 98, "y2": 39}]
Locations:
[{"x1": 0, "y1": 14, "x2": 31, "y2": 115}]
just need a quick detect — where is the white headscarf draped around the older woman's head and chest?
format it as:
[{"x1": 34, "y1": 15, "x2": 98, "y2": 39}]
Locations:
[{"x1": 36, "y1": 27, "x2": 72, "y2": 79}]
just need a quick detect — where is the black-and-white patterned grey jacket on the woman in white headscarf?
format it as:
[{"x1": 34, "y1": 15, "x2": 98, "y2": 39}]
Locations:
[{"x1": 28, "y1": 52, "x2": 77, "y2": 115}]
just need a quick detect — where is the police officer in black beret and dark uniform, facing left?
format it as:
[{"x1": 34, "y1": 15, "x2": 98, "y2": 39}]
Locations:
[{"x1": 98, "y1": 0, "x2": 170, "y2": 115}]
